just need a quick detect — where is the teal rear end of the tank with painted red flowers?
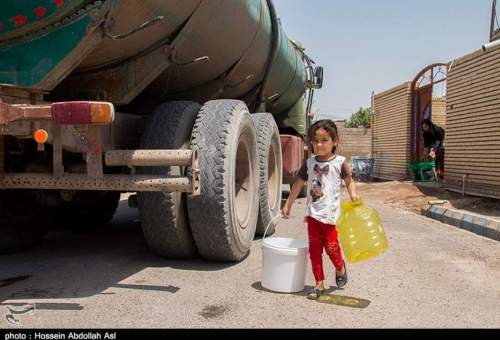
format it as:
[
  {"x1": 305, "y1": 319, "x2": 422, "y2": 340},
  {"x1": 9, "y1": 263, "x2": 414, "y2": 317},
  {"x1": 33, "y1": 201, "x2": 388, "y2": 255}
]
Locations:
[{"x1": 0, "y1": 0, "x2": 97, "y2": 89}]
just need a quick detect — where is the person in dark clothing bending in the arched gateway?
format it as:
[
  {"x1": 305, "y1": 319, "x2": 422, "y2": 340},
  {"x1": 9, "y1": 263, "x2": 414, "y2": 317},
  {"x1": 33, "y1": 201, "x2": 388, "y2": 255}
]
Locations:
[{"x1": 421, "y1": 119, "x2": 445, "y2": 182}]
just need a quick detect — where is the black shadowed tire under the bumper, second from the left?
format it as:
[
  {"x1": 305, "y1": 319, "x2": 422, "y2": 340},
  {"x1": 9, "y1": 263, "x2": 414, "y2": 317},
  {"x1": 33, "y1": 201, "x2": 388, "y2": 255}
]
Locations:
[{"x1": 56, "y1": 191, "x2": 120, "y2": 230}]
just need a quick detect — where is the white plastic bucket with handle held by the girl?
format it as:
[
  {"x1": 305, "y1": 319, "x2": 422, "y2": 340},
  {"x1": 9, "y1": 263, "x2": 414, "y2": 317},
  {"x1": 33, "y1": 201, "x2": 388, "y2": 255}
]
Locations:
[{"x1": 262, "y1": 216, "x2": 308, "y2": 293}]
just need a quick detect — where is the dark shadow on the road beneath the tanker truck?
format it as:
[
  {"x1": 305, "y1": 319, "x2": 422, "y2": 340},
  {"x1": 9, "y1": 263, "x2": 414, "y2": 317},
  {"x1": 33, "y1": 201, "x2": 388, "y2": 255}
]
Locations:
[{"x1": 0, "y1": 201, "x2": 235, "y2": 310}]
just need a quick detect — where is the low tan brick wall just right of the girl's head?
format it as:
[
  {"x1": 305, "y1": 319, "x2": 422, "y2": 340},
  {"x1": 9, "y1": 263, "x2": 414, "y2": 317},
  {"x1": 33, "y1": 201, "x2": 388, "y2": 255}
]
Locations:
[{"x1": 335, "y1": 121, "x2": 372, "y2": 159}]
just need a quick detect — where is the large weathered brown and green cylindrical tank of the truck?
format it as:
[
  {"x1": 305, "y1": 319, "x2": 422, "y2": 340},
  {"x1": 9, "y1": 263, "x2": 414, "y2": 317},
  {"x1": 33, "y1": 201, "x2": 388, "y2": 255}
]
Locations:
[{"x1": 0, "y1": 0, "x2": 306, "y2": 133}]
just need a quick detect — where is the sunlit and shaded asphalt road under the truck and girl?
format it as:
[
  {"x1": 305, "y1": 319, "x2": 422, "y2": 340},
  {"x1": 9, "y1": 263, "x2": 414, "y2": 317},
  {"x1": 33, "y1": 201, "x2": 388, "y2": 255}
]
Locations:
[{"x1": 0, "y1": 193, "x2": 500, "y2": 328}]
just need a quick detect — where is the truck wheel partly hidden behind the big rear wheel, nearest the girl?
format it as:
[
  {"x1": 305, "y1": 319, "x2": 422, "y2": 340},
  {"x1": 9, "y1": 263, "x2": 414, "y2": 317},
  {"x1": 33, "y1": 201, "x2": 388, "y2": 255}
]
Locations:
[{"x1": 252, "y1": 113, "x2": 283, "y2": 236}]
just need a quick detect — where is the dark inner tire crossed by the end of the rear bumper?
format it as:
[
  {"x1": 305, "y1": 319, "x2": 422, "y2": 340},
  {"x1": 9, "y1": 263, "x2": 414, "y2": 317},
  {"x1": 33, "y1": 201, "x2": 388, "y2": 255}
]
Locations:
[{"x1": 137, "y1": 101, "x2": 201, "y2": 259}]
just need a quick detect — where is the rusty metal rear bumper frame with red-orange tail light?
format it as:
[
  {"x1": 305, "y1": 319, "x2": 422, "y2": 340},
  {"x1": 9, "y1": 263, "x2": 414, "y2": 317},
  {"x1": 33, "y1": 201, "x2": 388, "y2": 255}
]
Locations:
[{"x1": 0, "y1": 102, "x2": 200, "y2": 195}]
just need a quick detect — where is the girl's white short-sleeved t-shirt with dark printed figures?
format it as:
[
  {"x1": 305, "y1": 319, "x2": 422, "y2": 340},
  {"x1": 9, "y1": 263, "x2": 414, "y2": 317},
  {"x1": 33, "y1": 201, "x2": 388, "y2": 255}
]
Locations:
[{"x1": 299, "y1": 156, "x2": 352, "y2": 225}]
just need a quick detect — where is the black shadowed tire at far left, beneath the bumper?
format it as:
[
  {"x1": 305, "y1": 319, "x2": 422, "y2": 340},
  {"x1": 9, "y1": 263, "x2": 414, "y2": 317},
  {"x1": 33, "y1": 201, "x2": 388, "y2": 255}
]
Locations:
[{"x1": 0, "y1": 190, "x2": 51, "y2": 254}]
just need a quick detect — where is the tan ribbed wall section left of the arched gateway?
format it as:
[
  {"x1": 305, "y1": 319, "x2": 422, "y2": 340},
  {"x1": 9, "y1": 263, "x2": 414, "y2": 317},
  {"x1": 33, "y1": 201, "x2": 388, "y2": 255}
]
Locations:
[{"x1": 372, "y1": 82, "x2": 411, "y2": 180}]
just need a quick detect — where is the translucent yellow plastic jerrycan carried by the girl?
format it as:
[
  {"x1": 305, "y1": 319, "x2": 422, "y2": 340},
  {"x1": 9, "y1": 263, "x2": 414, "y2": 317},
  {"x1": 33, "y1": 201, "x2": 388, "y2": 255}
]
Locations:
[{"x1": 337, "y1": 200, "x2": 388, "y2": 263}]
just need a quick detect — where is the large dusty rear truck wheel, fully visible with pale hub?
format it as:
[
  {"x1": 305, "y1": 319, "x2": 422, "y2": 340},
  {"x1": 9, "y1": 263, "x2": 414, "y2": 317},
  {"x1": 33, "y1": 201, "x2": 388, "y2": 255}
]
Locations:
[{"x1": 188, "y1": 100, "x2": 259, "y2": 261}]
